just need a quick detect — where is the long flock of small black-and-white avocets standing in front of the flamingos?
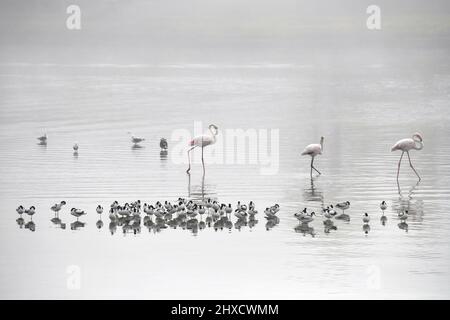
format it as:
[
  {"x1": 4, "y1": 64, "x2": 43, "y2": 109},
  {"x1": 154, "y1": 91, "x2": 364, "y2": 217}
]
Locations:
[{"x1": 16, "y1": 198, "x2": 408, "y2": 236}]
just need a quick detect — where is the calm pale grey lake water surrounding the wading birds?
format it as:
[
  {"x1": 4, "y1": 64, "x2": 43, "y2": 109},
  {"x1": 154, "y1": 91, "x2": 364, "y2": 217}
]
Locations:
[{"x1": 0, "y1": 52, "x2": 450, "y2": 299}]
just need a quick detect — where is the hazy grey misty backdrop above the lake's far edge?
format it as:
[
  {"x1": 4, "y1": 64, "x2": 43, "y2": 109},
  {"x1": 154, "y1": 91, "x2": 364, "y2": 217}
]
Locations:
[{"x1": 0, "y1": 0, "x2": 450, "y2": 65}]
